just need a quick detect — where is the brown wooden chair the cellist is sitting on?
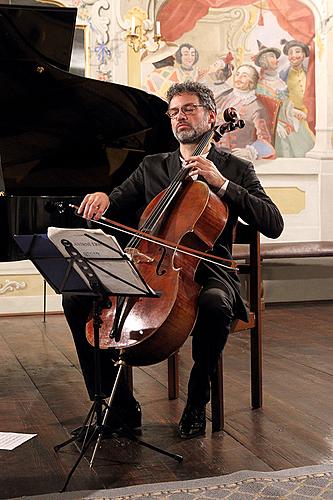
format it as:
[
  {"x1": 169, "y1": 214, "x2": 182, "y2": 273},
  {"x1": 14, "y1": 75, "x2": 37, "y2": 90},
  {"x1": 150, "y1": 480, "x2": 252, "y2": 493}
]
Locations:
[{"x1": 168, "y1": 223, "x2": 262, "y2": 432}]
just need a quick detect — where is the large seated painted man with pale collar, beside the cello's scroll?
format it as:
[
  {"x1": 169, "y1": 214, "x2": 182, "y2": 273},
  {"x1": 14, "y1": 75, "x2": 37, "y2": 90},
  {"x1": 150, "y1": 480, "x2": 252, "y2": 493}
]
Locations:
[{"x1": 217, "y1": 64, "x2": 275, "y2": 161}]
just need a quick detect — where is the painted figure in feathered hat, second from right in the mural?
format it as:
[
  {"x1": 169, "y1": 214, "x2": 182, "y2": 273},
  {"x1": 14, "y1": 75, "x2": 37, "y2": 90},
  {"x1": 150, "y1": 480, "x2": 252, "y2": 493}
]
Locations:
[{"x1": 252, "y1": 40, "x2": 288, "y2": 149}]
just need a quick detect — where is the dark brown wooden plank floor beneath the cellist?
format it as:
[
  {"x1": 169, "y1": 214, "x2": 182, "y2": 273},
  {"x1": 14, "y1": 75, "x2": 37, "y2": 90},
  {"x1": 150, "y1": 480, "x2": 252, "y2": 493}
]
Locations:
[{"x1": 0, "y1": 302, "x2": 333, "y2": 498}]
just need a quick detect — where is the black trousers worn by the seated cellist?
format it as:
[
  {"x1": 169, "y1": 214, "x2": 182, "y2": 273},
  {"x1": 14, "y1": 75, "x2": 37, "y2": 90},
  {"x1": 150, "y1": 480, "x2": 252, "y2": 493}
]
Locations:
[{"x1": 63, "y1": 278, "x2": 236, "y2": 407}]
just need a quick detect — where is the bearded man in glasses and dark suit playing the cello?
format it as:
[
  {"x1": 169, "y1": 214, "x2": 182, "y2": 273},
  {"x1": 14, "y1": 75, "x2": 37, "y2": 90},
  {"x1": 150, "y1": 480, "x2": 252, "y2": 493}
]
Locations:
[{"x1": 63, "y1": 81, "x2": 283, "y2": 439}]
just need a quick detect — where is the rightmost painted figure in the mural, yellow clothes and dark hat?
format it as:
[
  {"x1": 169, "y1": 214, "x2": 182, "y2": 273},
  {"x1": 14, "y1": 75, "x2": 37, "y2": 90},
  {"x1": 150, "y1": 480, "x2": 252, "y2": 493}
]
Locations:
[{"x1": 275, "y1": 40, "x2": 315, "y2": 158}]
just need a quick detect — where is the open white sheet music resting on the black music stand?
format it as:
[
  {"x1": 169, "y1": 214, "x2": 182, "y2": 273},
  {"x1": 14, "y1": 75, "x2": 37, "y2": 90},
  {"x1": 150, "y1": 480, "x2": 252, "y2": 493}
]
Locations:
[{"x1": 47, "y1": 227, "x2": 151, "y2": 295}]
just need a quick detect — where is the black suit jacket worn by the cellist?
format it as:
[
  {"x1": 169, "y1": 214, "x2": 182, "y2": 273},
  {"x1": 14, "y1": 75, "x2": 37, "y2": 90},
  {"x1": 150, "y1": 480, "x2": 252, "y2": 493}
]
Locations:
[{"x1": 109, "y1": 147, "x2": 283, "y2": 318}]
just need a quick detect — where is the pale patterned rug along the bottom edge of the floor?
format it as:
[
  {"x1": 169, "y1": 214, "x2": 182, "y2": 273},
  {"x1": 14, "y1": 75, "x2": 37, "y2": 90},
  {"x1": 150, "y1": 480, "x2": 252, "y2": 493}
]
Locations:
[{"x1": 12, "y1": 463, "x2": 333, "y2": 500}]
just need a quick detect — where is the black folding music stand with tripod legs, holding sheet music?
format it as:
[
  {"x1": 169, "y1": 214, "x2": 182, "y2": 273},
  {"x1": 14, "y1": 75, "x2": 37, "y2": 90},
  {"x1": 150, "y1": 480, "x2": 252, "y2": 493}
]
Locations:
[{"x1": 14, "y1": 228, "x2": 183, "y2": 492}]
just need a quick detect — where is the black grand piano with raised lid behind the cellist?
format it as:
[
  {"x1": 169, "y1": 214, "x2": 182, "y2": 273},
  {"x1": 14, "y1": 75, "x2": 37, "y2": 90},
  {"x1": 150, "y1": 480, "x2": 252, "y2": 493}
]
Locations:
[{"x1": 0, "y1": 5, "x2": 176, "y2": 261}]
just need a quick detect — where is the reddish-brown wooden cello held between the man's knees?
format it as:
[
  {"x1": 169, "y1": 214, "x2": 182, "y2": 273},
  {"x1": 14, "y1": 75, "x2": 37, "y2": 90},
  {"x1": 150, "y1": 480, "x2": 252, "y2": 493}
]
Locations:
[{"x1": 86, "y1": 108, "x2": 244, "y2": 366}]
